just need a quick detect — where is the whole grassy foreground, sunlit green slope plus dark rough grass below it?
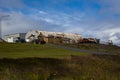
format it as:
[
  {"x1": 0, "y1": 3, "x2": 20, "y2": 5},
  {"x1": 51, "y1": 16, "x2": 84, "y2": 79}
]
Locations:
[{"x1": 0, "y1": 43, "x2": 120, "y2": 80}]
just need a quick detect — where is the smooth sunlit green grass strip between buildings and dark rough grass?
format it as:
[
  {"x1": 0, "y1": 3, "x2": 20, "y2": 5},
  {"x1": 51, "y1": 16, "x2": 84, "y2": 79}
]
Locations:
[{"x1": 0, "y1": 43, "x2": 87, "y2": 58}]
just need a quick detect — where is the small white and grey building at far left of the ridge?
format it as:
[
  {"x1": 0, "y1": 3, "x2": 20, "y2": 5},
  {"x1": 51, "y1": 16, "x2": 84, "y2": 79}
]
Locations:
[{"x1": 4, "y1": 33, "x2": 26, "y2": 43}]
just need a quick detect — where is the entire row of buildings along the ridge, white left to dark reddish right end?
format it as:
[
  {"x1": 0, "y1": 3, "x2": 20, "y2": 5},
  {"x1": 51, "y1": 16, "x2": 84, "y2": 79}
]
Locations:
[{"x1": 4, "y1": 30, "x2": 100, "y2": 44}]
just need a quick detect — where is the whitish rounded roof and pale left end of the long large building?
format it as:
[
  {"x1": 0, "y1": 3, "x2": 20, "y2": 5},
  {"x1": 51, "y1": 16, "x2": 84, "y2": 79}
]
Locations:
[{"x1": 25, "y1": 30, "x2": 82, "y2": 43}]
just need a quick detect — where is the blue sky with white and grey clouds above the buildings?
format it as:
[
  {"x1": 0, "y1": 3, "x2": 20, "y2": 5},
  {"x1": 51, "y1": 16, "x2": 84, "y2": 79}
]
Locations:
[{"x1": 0, "y1": 0, "x2": 120, "y2": 45}]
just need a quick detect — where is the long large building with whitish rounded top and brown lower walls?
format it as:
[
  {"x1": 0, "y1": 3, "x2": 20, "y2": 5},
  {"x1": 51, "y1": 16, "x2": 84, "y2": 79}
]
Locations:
[{"x1": 25, "y1": 30, "x2": 82, "y2": 44}]
